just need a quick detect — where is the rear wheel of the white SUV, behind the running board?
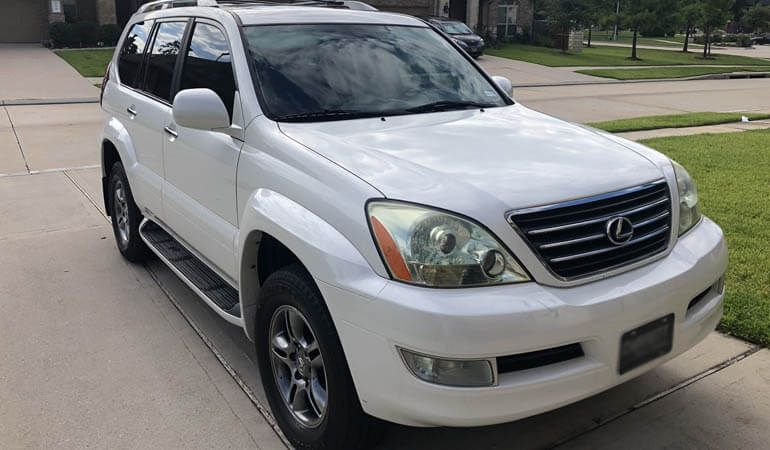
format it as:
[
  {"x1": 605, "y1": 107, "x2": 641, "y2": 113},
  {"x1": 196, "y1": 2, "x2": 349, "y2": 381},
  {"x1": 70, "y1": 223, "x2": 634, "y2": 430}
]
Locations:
[{"x1": 107, "y1": 162, "x2": 152, "y2": 263}]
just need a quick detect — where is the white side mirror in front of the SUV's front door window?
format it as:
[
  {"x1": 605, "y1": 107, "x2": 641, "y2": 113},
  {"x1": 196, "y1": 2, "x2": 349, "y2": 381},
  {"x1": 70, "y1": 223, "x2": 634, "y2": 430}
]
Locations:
[{"x1": 172, "y1": 89, "x2": 230, "y2": 132}]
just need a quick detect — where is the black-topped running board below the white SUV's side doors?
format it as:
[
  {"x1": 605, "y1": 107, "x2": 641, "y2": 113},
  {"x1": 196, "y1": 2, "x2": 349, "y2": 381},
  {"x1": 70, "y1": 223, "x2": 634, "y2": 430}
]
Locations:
[{"x1": 139, "y1": 219, "x2": 241, "y2": 320}]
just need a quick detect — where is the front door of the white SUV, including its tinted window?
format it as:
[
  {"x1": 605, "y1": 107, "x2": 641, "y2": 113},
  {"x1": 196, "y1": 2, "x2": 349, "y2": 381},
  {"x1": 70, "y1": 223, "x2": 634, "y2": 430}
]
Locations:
[{"x1": 163, "y1": 19, "x2": 243, "y2": 282}]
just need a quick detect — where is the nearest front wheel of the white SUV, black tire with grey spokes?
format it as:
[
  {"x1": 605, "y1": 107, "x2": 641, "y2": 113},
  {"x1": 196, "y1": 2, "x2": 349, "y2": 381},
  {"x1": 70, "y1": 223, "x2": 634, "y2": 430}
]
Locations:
[{"x1": 255, "y1": 264, "x2": 383, "y2": 450}]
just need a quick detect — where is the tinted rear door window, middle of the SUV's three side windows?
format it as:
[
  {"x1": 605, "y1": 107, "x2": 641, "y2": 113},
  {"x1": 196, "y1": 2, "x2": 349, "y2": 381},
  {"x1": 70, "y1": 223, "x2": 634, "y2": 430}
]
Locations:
[{"x1": 144, "y1": 22, "x2": 187, "y2": 102}]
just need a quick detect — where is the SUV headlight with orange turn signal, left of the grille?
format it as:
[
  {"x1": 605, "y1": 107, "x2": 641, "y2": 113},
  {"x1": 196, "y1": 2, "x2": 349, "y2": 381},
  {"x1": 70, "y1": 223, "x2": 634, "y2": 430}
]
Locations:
[{"x1": 367, "y1": 201, "x2": 529, "y2": 287}]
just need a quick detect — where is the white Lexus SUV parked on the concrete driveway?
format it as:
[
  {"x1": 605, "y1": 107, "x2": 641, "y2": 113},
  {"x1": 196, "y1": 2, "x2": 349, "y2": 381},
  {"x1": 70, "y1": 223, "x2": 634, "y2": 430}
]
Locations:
[{"x1": 101, "y1": 0, "x2": 727, "y2": 449}]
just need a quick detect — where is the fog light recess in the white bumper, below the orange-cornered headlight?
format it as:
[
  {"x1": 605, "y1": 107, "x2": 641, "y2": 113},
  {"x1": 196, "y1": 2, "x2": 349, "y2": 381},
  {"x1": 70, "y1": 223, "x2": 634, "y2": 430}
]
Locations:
[{"x1": 399, "y1": 348, "x2": 495, "y2": 387}]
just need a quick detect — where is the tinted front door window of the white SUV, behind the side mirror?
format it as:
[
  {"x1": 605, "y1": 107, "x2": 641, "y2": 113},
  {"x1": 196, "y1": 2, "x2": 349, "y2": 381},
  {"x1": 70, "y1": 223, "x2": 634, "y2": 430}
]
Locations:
[{"x1": 179, "y1": 23, "x2": 235, "y2": 119}]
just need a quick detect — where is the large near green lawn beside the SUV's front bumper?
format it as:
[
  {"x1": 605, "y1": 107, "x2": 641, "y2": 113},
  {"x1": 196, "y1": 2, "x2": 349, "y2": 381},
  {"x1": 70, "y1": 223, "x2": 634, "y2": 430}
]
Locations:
[{"x1": 643, "y1": 130, "x2": 770, "y2": 346}]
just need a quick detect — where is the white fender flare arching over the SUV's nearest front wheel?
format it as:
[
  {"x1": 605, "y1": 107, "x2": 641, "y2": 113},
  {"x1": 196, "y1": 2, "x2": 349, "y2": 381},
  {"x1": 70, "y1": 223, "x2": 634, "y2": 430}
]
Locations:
[{"x1": 237, "y1": 189, "x2": 376, "y2": 341}]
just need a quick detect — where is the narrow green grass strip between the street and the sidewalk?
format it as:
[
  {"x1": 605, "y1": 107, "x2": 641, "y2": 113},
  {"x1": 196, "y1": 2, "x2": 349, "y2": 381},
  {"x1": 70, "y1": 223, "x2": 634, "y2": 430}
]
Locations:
[{"x1": 586, "y1": 112, "x2": 770, "y2": 133}]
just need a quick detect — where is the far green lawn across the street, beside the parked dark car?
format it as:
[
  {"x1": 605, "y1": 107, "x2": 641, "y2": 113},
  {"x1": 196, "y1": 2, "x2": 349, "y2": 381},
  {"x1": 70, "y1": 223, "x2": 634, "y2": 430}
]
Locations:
[{"x1": 486, "y1": 44, "x2": 768, "y2": 67}]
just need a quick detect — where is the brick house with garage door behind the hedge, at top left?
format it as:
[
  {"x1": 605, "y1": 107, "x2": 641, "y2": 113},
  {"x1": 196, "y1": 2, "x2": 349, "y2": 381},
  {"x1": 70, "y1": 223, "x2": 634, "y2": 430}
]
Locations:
[{"x1": 0, "y1": 0, "x2": 116, "y2": 43}]
